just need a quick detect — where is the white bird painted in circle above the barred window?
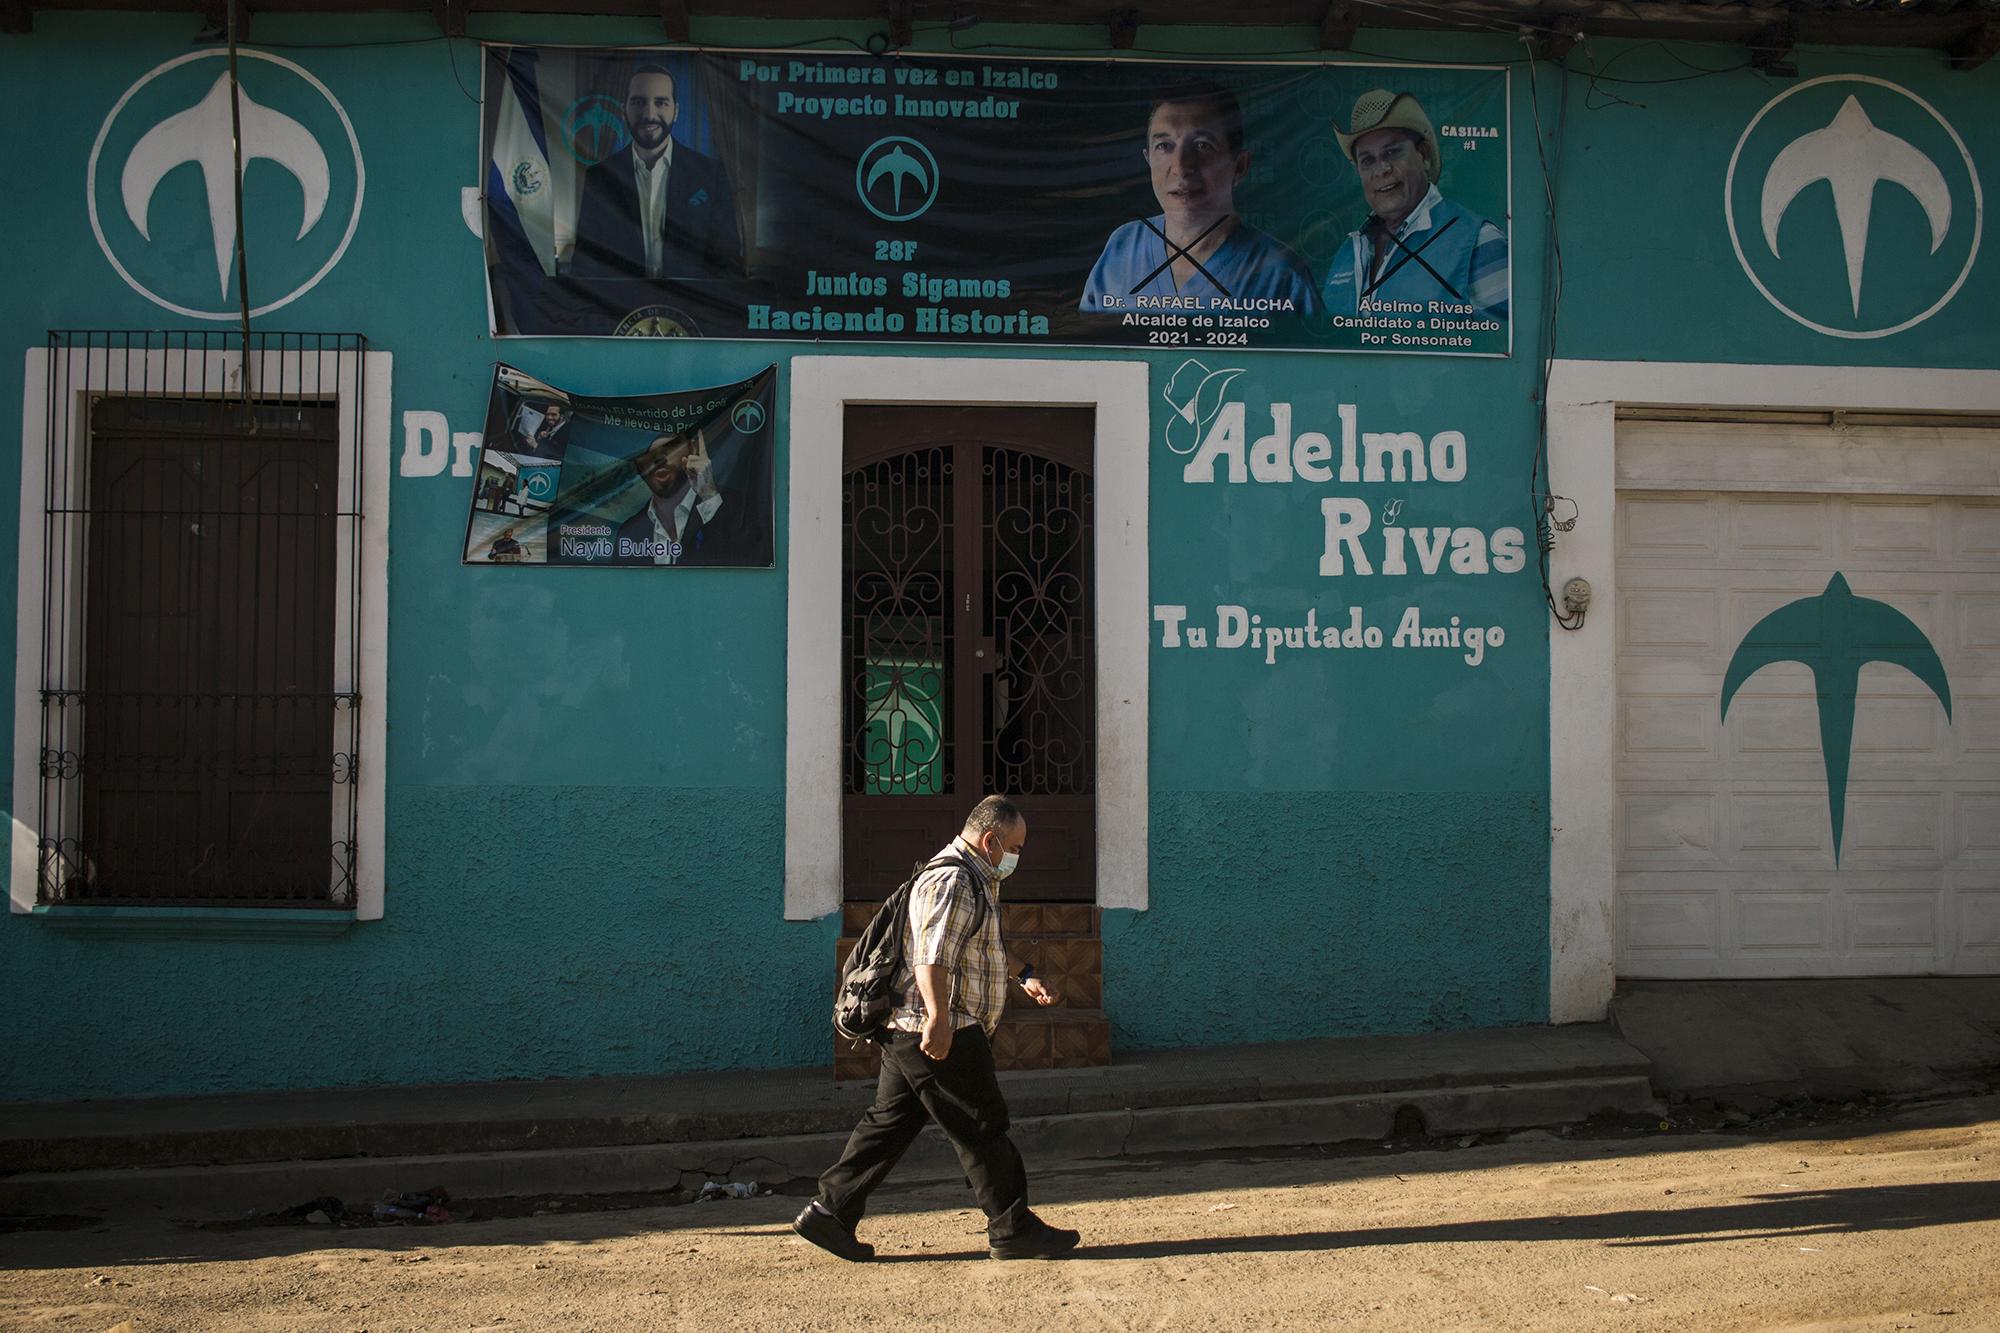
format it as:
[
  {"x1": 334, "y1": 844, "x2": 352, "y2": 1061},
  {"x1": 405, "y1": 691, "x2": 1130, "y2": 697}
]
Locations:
[{"x1": 118, "y1": 74, "x2": 332, "y2": 300}]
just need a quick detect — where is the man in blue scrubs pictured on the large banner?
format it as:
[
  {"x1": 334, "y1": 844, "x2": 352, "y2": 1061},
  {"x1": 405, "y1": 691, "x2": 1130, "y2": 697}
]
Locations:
[{"x1": 1076, "y1": 80, "x2": 1320, "y2": 314}]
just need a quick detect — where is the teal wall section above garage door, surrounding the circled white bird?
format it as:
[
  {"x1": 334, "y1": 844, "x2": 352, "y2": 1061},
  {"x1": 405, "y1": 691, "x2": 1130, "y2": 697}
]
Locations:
[{"x1": 1560, "y1": 46, "x2": 2000, "y2": 368}]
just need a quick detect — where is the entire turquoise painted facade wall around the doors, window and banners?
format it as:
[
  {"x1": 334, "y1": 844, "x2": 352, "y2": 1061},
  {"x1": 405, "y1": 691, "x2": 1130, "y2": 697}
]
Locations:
[{"x1": 0, "y1": 14, "x2": 2000, "y2": 1099}]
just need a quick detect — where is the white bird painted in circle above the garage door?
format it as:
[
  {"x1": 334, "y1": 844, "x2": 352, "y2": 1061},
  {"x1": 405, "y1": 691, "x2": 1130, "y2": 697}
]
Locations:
[{"x1": 1762, "y1": 96, "x2": 1952, "y2": 318}]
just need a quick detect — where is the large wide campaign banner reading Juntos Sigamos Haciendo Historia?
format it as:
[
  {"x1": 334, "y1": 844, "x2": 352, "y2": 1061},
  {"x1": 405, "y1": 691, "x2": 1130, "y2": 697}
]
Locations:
[{"x1": 480, "y1": 46, "x2": 1512, "y2": 356}]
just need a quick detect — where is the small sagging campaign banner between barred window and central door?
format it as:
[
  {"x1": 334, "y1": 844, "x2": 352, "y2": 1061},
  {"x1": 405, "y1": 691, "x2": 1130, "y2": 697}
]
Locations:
[{"x1": 462, "y1": 366, "x2": 778, "y2": 568}]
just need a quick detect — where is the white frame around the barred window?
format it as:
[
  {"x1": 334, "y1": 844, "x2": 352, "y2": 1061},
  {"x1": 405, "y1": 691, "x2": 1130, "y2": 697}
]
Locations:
[{"x1": 8, "y1": 346, "x2": 394, "y2": 921}]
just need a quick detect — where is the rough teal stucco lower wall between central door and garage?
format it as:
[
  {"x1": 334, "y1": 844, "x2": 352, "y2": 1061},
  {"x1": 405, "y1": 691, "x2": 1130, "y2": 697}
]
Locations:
[{"x1": 1104, "y1": 793, "x2": 1548, "y2": 1051}]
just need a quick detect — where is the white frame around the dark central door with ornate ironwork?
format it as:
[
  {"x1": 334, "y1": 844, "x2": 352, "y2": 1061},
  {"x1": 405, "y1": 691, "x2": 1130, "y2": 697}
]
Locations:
[{"x1": 784, "y1": 356, "x2": 1152, "y2": 921}]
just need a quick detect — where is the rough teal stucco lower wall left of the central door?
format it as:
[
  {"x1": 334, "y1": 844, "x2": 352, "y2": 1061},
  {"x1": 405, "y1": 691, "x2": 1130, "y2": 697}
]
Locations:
[{"x1": 11, "y1": 787, "x2": 836, "y2": 1099}]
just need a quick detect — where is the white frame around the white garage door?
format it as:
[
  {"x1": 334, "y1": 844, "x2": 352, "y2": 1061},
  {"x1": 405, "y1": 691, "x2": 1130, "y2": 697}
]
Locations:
[{"x1": 1548, "y1": 360, "x2": 2000, "y2": 1023}]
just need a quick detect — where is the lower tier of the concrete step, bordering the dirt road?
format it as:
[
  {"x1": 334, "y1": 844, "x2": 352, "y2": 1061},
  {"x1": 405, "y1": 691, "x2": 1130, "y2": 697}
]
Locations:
[{"x1": 0, "y1": 1073, "x2": 1658, "y2": 1221}]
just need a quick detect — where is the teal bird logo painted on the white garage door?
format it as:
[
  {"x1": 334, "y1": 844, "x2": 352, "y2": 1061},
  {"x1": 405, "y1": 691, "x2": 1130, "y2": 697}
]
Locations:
[{"x1": 1722, "y1": 572, "x2": 1952, "y2": 865}]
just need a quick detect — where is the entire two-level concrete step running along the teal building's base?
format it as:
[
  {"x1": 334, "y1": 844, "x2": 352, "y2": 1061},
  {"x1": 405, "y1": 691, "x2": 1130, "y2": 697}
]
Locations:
[{"x1": 0, "y1": 1025, "x2": 1654, "y2": 1217}]
